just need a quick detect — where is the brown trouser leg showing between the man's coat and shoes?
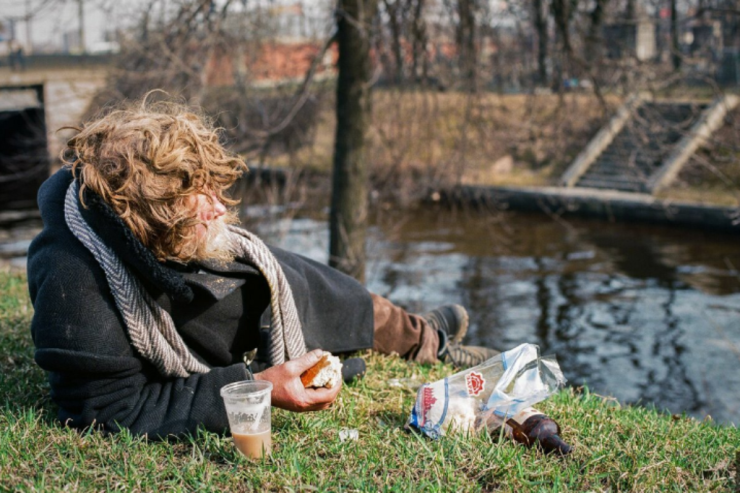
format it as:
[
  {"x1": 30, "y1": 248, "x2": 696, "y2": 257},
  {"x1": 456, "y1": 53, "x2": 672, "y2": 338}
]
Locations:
[{"x1": 371, "y1": 293, "x2": 439, "y2": 363}]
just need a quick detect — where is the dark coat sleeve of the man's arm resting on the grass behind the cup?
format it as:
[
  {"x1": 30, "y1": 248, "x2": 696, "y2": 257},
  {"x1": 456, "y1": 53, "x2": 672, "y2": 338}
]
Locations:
[{"x1": 28, "y1": 238, "x2": 247, "y2": 438}]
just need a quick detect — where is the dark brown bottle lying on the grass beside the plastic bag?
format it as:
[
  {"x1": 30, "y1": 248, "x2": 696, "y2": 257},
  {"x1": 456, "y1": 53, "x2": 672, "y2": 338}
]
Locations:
[{"x1": 504, "y1": 407, "x2": 572, "y2": 455}]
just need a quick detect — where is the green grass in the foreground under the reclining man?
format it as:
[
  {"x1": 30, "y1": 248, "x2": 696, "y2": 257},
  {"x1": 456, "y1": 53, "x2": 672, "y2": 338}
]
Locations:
[{"x1": 0, "y1": 273, "x2": 740, "y2": 492}]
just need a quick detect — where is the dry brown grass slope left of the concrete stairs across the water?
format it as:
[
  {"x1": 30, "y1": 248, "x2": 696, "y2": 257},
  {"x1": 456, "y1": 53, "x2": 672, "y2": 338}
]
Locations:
[{"x1": 268, "y1": 89, "x2": 619, "y2": 191}]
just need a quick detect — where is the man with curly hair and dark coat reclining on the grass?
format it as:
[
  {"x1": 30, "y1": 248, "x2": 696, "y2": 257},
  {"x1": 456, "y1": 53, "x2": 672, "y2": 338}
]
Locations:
[{"x1": 28, "y1": 103, "x2": 493, "y2": 437}]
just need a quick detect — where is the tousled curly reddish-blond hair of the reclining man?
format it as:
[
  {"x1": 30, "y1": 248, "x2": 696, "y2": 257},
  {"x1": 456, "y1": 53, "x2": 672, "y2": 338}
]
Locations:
[{"x1": 62, "y1": 97, "x2": 247, "y2": 263}]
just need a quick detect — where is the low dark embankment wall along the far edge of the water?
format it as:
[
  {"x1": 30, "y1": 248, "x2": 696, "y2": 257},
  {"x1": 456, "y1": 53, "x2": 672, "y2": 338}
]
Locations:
[{"x1": 244, "y1": 167, "x2": 740, "y2": 233}]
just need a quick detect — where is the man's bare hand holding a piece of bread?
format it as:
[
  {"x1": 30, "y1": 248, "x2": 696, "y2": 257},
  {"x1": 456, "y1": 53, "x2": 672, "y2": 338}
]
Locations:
[{"x1": 254, "y1": 349, "x2": 342, "y2": 412}]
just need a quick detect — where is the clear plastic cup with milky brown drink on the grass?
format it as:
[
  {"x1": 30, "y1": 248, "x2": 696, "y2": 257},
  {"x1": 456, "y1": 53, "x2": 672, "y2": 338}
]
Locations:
[{"x1": 221, "y1": 380, "x2": 272, "y2": 459}]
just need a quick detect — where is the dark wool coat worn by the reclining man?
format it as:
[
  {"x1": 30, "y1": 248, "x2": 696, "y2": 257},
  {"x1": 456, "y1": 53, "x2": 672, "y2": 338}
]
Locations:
[{"x1": 28, "y1": 169, "x2": 373, "y2": 437}]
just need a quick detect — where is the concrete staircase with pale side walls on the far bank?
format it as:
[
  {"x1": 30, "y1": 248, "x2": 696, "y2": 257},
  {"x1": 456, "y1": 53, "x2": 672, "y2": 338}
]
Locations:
[{"x1": 561, "y1": 96, "x2": 737, "y2": 193}]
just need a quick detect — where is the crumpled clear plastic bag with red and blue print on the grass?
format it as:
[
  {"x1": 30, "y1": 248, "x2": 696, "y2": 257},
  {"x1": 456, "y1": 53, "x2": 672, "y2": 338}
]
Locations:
[{"x1": 406, "y1": 344, "x2": 565, "y2": 438}]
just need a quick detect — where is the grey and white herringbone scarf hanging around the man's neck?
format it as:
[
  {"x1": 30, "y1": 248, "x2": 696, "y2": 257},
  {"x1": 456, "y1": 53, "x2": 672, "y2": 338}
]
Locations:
[{"x1": 64, "y1": 180, "x2": 306, "y2": 377}]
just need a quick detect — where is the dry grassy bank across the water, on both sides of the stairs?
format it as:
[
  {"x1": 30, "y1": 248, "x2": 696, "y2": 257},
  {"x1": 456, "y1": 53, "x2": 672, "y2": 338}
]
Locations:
[{"x1": 258, "y1": 89, "x2": 740, "y2": 206}]
